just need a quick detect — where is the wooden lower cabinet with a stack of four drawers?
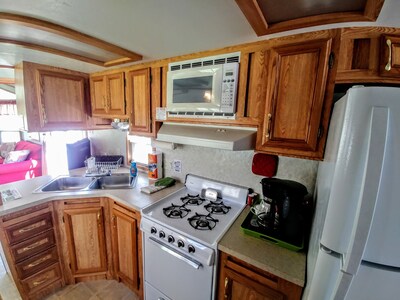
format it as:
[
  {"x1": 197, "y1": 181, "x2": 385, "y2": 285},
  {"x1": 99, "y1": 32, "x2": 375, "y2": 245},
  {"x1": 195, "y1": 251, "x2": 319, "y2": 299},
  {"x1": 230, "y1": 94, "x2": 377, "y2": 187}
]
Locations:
[{"x1": 0, "y1": 202, "x2": 65, "y2": 299}]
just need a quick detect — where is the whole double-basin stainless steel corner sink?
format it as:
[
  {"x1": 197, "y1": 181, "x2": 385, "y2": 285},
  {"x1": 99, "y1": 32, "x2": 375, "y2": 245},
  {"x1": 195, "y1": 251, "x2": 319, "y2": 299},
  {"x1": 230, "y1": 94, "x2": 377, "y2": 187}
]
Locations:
[{"x1": 34, "y1": 174, "x2": 136, "y2": 193}]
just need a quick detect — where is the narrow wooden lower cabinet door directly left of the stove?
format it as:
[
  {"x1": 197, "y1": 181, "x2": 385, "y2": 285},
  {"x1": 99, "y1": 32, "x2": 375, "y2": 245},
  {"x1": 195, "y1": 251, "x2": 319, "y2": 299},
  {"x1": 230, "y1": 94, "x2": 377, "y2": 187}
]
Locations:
[{"x1": 111, "y1": 202, "x2": 143, "y2": 295}]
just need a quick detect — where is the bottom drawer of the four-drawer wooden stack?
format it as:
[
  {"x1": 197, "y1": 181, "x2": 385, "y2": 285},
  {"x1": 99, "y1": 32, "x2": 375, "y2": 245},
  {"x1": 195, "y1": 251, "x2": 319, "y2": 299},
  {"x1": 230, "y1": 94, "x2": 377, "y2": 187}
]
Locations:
[{"x1": 21, "y1": 263, "x2": 61, "y2": 294}]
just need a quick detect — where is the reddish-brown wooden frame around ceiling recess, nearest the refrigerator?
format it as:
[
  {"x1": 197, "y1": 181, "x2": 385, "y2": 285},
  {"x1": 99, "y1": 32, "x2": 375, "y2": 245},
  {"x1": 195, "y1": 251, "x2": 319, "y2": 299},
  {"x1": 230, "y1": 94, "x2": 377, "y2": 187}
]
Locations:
[{"x1": 235, "y1": 0, "x2": 385, "y2": 36}]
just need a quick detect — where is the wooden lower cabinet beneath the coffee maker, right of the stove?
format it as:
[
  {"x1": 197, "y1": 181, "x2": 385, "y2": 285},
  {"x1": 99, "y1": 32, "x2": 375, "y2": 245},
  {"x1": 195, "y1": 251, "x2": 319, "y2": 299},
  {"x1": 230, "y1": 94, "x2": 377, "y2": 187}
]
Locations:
[{"x1": 218, "y1": 252, "x2": 302, "y2": 300}]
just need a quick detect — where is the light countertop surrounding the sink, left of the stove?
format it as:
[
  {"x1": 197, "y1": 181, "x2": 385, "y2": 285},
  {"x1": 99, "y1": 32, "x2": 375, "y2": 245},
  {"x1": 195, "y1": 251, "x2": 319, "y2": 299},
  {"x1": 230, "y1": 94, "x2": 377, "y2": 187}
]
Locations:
[{"x1": 0, "y1": 168, "x2": 183, "y2": 216}]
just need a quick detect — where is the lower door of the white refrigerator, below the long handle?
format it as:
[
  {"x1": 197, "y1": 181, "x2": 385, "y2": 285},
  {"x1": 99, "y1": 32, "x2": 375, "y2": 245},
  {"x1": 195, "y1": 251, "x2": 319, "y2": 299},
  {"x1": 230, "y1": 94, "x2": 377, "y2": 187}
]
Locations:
[{"x1": 346, "y1": 262, "x2": 400, "y2": 300}]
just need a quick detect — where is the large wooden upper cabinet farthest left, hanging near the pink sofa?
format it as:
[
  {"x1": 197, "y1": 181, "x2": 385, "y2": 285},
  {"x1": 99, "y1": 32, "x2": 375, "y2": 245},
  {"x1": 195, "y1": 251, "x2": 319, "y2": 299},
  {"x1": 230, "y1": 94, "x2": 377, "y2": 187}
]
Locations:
[{"x1": 15, "y1": 62, "x2": 89, "y2": 131}]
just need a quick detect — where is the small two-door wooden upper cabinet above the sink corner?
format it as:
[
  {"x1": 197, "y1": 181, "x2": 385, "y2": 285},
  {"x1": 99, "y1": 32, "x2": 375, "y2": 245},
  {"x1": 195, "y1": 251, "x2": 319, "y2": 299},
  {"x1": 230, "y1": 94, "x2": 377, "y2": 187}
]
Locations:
[{"x1": 90, "y1": 72, "x2": 127, "y2": 118}]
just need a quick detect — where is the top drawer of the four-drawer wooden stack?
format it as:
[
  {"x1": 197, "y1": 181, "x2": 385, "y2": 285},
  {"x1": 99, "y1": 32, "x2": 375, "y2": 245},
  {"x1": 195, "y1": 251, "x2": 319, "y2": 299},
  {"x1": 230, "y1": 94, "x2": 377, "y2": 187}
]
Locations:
[{"x1": 5, "y1": 212, "x2": 53, "y2": 245}]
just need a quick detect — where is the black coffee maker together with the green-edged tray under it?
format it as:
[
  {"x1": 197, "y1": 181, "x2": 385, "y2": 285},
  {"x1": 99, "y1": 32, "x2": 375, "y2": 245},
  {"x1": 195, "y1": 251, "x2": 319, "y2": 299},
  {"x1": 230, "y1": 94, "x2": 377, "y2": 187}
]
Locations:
[{"x1": 241, "y1": 178, "x2": 311, "y2": 251}]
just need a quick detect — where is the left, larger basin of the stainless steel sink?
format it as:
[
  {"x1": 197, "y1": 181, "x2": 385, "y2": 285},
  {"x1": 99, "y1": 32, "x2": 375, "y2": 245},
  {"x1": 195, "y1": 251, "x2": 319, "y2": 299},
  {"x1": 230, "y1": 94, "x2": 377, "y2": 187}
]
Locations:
[{"x1": 35, "y1": 176, "x2": 96, "y2": 193}]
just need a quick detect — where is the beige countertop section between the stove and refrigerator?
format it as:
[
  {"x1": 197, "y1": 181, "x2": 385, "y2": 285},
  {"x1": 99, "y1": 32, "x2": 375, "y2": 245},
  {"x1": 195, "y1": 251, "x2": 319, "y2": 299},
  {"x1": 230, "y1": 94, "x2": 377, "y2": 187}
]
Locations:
[{"x1": 218, "y1": 207, "x2": 306, "y2": 287}]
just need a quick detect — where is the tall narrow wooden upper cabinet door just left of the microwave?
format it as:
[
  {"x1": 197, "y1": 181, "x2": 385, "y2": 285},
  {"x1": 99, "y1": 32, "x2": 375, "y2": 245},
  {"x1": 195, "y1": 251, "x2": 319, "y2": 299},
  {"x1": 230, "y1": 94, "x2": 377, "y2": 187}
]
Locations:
[{"x1": 126, "y1": 69, "x2": 151, "y2": 133}]
